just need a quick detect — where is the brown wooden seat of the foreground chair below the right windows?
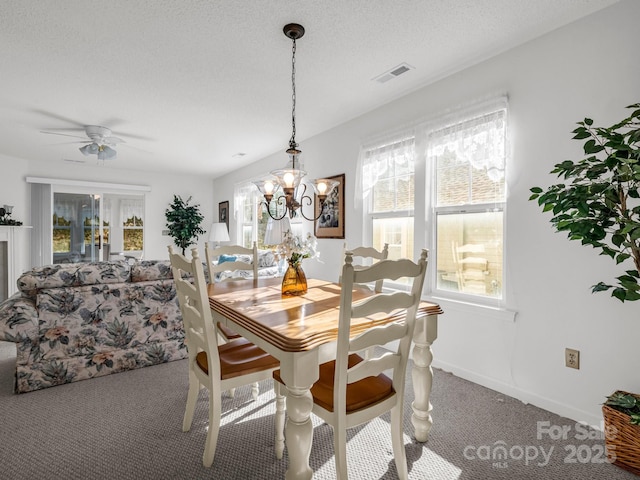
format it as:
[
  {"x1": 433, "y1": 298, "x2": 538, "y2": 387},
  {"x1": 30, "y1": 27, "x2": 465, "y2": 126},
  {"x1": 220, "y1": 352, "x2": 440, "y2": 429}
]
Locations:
[{"x1": 273, "y1": 354, "x2": 395, "y2": 413}]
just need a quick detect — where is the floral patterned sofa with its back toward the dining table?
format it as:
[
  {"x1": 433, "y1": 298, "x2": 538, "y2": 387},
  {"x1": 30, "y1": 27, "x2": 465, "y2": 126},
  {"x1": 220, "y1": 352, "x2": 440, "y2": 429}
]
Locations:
[{"x1": 0, "y1": 261, "x2": 187, "y2": 393}]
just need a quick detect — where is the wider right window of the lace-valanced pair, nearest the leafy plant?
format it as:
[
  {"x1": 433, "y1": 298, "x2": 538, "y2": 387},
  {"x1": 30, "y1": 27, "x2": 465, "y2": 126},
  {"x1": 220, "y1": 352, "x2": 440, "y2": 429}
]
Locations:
[{"x1": 426, "y1": 108, "x2": 506, "y2": 299}]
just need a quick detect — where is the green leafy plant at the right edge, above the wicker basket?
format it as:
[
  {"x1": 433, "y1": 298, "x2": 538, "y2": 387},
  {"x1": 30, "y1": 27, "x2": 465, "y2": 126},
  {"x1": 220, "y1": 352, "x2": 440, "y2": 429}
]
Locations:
[{"x1": 529, "y1": 103, "x2": 640, "y2": 302}]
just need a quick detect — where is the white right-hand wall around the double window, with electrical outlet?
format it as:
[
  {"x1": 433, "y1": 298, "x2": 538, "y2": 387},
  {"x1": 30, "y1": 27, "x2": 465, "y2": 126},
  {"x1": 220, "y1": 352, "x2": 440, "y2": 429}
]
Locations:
[{"x1": 214, "y1": 0, "x2": 640, "y2": 428}]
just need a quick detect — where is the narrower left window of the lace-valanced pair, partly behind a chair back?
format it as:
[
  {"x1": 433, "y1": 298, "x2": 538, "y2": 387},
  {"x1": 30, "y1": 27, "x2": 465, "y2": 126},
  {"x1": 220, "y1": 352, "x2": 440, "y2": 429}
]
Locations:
[{"x1": 361, "y1": 136, "x2": 415, "y2": 282}]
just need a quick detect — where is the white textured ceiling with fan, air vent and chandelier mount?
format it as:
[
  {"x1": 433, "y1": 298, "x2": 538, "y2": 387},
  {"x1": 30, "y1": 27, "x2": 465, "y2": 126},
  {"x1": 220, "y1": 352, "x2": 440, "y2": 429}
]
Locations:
[{"x1": 0, "y1": 0, "x2": 617, "y2": 177}]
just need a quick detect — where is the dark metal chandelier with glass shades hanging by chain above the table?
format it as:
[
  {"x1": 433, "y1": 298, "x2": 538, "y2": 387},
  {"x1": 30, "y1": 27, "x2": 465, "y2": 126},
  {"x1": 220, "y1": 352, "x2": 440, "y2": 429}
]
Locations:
[{"x1": 253, "y1": 23, "x2": 338, "y2": 220}]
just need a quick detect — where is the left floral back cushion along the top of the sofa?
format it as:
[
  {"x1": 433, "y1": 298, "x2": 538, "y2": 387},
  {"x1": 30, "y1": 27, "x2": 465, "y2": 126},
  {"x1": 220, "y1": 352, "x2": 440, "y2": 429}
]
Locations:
[{"x1": 18, "y1": 261, "x2": 131, "y2": 300}]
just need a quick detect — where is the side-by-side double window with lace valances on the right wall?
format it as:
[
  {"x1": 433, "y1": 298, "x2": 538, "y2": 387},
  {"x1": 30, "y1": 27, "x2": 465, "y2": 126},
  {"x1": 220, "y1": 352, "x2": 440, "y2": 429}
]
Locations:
[{"x1": 358, "y1": 98, "x2": 507, "y2": 303}]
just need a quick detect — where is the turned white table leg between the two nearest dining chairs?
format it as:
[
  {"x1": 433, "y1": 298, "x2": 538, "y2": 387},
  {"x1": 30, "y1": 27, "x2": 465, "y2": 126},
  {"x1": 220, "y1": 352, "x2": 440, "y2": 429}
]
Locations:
[{"x1": 284, "y1": 387, "x2": 313, "y2": 480}]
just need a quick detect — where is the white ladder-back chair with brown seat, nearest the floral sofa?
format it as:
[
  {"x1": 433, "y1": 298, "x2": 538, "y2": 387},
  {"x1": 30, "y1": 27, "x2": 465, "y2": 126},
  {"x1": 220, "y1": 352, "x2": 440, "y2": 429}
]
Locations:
[{"x1": 169, "y1": 246, "x2": 279, "y2": 467}]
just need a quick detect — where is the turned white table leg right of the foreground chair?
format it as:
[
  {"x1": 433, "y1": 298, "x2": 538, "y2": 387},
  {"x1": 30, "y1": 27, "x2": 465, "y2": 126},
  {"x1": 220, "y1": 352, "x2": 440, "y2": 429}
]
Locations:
[{"x1": 411, "y1": 315, "x2": 438, "y2": 442}]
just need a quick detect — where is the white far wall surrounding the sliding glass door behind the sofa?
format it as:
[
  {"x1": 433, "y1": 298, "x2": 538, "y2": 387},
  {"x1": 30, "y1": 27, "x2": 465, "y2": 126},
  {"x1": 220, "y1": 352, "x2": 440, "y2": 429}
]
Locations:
[{"x1": 0, "y1": 156, "x2": 218, "y2": 260}]
